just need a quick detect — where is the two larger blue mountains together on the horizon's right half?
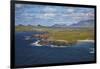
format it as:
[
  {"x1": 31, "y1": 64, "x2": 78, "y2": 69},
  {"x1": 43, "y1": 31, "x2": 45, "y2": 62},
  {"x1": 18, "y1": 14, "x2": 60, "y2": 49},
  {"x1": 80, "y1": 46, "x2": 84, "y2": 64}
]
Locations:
[{"x1": 52, "y1": 19, "x2": 94, "y2": 27}]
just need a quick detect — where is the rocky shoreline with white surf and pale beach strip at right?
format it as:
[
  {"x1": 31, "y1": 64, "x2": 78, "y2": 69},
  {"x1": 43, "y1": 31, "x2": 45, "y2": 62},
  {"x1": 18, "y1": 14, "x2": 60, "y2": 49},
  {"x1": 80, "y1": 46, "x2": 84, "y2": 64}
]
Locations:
[{"x1": 25, "y1": 33, "x2": 94, "y2": 47}]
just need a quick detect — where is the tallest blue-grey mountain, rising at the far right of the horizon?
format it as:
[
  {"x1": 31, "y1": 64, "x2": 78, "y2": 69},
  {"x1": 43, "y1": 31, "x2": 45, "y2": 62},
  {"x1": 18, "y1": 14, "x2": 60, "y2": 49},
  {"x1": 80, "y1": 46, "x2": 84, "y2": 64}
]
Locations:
[{"x1": 70, "y1": 19, "x2": 94, "y2": 27}]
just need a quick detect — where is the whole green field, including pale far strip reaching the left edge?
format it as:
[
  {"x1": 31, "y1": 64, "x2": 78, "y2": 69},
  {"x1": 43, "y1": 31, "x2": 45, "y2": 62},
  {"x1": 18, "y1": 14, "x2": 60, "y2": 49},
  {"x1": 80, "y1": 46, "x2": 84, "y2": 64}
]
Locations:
[{"x1": 15, "y1": 26, "x2": 94, "y2": 42}]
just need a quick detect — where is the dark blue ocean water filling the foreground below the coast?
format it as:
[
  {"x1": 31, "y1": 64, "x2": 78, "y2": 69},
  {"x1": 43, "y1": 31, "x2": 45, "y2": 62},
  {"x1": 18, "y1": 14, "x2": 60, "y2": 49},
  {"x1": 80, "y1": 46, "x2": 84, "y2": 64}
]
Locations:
[{"x1": 15, "y1": 32, "x2": 95, "y2": 66}]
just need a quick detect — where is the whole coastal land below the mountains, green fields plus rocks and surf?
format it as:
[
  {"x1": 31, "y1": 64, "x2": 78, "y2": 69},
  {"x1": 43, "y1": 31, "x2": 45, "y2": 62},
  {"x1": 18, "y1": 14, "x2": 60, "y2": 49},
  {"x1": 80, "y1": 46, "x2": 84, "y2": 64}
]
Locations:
[{"x1": 15, "y1": 25, "x2": 94, "y2": 47}]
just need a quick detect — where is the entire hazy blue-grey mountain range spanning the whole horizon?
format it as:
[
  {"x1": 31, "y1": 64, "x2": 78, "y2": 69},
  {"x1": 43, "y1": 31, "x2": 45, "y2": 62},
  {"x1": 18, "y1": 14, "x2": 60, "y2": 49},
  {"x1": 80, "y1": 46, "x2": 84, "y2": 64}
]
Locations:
[{"x1": 16, "y1": 19, "x2": 94, "y2": 28}]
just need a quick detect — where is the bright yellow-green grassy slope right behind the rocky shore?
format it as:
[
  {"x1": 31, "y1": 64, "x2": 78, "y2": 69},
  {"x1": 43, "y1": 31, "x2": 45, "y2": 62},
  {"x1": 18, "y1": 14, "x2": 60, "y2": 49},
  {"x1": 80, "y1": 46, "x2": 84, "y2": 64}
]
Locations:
[{"x1": 48, "y1": 30, "x2": 94, "y2": 41}]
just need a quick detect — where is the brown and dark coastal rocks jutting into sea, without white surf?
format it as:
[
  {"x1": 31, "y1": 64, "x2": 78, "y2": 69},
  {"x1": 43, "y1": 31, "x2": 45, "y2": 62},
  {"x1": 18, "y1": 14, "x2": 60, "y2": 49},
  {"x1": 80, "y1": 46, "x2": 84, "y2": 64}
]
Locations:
[{"x1": 26, "y1": 33, "x2": 76, "y2": 46}]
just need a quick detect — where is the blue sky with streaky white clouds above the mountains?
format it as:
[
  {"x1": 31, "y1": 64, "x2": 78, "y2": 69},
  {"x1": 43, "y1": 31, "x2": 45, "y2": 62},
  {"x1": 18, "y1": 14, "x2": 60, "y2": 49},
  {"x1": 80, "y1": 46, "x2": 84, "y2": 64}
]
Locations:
[{"x1": 15, "y1": 4, "x2": 94, "y2": 26}]
